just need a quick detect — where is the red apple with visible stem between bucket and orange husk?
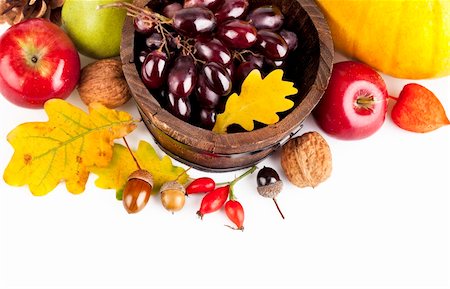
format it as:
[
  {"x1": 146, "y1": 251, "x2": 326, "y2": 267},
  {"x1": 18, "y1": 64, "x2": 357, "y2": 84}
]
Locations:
[{"x1": 313, "y1": 61, "x2": 388, "y2": 140}]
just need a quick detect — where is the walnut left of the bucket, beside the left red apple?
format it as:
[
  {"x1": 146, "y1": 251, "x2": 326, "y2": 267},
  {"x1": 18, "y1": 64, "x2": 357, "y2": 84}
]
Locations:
[{"x1": 78, "y1": 58, "x2": 131, "y2": 108}]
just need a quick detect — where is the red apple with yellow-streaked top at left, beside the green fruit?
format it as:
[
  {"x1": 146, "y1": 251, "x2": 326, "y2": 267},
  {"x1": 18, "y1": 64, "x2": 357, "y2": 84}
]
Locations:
[{"x1": 0, "y1": 19, "x2": 80, "y2": 108}]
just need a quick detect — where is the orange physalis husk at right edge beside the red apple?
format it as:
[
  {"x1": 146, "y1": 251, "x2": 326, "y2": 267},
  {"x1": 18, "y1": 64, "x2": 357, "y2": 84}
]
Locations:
[{"x1": 391, "y1": 83, "x2": 450, "y2": 133}]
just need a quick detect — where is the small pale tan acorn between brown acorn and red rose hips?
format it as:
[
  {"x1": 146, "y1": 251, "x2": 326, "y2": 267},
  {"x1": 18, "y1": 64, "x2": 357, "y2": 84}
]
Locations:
[{"x1": 159, "y1": 181, "x2": 186, "y2": 214}]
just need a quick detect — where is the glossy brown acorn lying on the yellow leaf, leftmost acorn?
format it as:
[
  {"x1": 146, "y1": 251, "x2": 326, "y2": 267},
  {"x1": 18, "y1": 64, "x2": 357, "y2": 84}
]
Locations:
[{"x1": 122, "y1": 170, "x2": 153, "y2": 214}]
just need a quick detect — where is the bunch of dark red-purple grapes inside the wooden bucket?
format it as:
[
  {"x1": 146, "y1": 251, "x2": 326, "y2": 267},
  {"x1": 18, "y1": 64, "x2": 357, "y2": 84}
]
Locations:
[{"x1": 129, "y1": 0, "x2": 298, "y2": 129}]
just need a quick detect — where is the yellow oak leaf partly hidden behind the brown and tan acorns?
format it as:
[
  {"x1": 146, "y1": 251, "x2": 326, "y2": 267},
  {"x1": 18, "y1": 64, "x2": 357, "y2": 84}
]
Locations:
[{"x1": 91, "y1": 141, "x2": 189, "y2": 200}]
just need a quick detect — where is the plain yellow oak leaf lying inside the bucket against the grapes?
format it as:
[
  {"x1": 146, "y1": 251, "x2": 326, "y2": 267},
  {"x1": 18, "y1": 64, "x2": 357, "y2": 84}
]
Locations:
[{"x1": 213, "y1": 69, "x2": 298, "y2": 133}]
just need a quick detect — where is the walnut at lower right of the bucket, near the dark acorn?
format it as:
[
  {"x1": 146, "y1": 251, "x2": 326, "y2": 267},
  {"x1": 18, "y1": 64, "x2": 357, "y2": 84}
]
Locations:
[{"x1": 281, "y1": 132, "x2": 332, "y2": 188}]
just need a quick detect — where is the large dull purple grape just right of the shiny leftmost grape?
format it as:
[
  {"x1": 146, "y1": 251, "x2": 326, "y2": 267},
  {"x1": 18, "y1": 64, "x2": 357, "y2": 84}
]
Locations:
[{"x1": 167, "y1": 55, "x2": 197, "y2": 97}]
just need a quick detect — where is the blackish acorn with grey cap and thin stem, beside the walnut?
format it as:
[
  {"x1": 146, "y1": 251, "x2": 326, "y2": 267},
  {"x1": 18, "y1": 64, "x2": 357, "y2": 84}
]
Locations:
[{"x1": 256, "y1": 167, "x2": 284, "y2": 219}]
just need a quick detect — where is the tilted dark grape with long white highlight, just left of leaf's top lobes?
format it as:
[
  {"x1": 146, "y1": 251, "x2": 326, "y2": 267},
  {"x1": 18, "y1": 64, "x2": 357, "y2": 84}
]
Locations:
[{"x1": 200, "y1": 62, "x2": 232, "y2": 95}]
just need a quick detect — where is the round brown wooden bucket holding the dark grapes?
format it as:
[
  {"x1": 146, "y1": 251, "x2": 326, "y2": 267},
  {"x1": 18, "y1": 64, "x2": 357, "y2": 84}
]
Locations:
[{"x1": 121, "y1": 0, "x2": 334, "y2": 171}]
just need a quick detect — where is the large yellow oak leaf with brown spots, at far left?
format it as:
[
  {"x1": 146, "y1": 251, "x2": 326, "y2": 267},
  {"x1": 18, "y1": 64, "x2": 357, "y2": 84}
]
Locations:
[{"x1": 3, "y1": 99, "x2": 136, "y2": 196}]
